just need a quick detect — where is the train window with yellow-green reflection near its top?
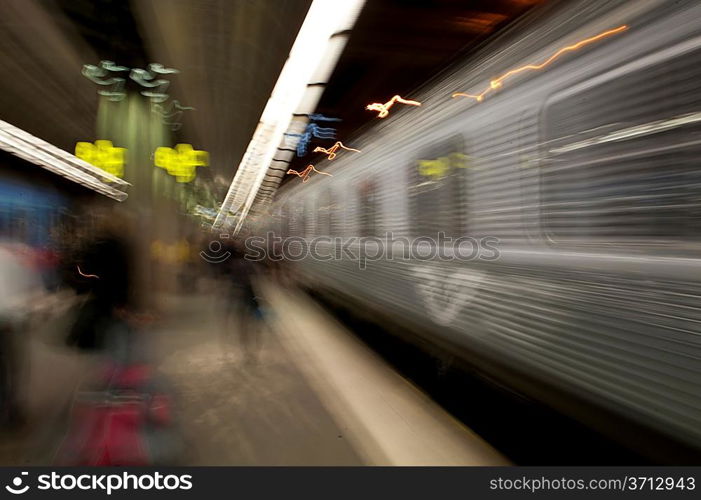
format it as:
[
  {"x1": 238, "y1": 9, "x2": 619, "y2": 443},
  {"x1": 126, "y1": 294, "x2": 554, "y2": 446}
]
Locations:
[{"x1": 409, "y1": 135, "x2": 469, "y2": 237}]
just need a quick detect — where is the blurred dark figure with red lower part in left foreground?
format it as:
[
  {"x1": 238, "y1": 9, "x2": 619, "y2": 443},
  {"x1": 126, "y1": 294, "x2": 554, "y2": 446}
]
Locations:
[{"x1": 54, "y1": 216, "x2": 180, "y2": 466}]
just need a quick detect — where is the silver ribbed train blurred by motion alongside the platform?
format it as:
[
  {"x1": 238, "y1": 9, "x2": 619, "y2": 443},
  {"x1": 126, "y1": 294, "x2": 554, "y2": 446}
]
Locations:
[{"x1": 273, "y1": 0, "x2": 701, "y2": 454}]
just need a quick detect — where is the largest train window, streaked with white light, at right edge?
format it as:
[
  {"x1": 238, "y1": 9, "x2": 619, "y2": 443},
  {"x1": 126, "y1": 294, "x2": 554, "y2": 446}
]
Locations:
[{"x1": 541, "y1": 44, "x2": 701, "y2": 243}]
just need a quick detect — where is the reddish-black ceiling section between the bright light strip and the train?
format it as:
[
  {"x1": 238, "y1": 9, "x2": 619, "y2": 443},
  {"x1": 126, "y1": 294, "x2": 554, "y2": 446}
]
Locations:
[{"x1": 283, "y1": 0, "x2": 542, "y2": 182}]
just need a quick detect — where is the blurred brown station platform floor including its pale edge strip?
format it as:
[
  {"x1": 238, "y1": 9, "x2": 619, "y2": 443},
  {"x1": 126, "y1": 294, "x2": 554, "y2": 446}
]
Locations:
[{"x1": 0, "y1": 283, "x2": 508, "y2": 465}]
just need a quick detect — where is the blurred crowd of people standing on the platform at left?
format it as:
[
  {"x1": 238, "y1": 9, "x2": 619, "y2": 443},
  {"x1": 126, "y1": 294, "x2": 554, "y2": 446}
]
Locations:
[{"x1": 0, "y1": 203, "x2": 284, "y2": 465}]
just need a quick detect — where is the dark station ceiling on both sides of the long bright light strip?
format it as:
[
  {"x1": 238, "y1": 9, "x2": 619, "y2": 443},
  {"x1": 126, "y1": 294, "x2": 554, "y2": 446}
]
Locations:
[{"x1": 0, "y1": 0, "x2": 539, "y2": 196}]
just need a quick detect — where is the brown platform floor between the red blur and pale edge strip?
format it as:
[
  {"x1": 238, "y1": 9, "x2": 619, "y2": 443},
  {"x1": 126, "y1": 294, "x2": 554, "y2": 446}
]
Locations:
[{"x1": 154, "y1": 296, "x2": 361, "y2": 465}]
